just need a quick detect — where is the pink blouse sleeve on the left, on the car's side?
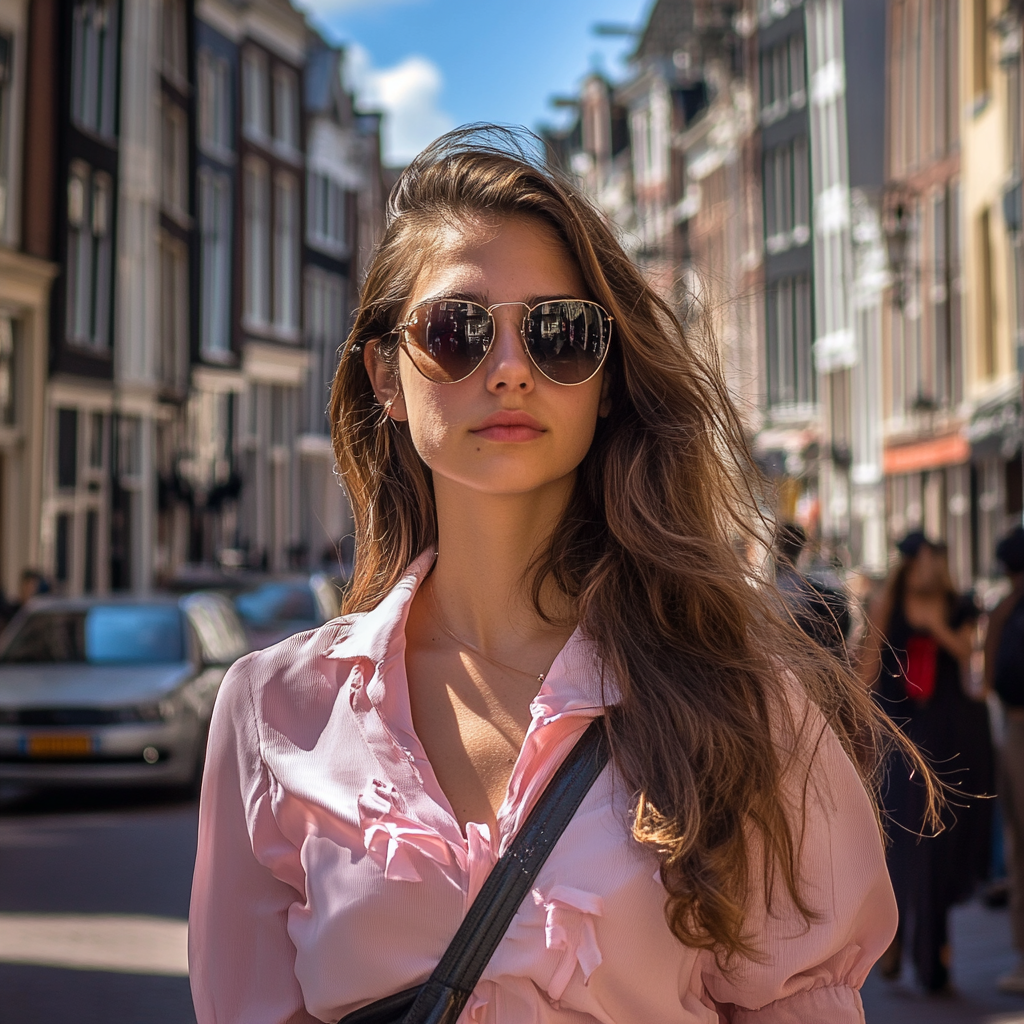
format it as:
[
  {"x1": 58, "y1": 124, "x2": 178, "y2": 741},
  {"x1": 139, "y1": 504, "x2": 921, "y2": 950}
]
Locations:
[{"x1": 188, "y1": 654, "x2": 315, "y2": 1024}]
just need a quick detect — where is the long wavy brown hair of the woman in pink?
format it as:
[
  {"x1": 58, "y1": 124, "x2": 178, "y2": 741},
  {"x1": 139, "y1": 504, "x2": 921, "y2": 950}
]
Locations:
[{"x1": 330, "y1": 126, "x2": 927, "y2": 959}]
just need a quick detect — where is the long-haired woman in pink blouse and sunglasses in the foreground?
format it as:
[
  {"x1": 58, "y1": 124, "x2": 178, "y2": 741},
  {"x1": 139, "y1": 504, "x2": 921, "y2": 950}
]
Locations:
[{"x1": 189, "y1": 129, "x2": 896, "y2": 1024}]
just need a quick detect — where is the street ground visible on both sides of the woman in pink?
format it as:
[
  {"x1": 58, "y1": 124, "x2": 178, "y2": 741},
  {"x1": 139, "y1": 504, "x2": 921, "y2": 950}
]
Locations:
[{"x1": 0, "y1": 792, "x2": 1024, "y2": 1024}]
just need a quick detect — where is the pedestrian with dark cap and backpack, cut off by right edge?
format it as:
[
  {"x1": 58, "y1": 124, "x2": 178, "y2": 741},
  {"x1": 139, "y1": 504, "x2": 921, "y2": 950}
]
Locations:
[{"x1": 985, "y1": 526, "x2": 1024, "y2": 994}]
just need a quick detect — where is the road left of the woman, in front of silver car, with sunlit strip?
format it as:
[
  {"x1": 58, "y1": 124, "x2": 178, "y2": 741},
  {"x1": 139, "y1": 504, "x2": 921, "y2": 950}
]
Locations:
[{"x1": 0, "y1": 792, "x2": 197, "y2": 1024}]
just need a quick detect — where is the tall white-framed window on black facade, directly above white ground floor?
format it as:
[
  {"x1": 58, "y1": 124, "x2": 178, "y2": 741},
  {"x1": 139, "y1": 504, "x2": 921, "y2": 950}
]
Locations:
[{"x1": 66, "y1": 160, "x2": 113, "y2": 349}]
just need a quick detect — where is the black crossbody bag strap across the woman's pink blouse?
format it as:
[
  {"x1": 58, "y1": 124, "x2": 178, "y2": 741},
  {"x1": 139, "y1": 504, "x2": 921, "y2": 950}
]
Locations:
[{"x1": 338, "y1": 718, "x2": 608, "y2": 1024}]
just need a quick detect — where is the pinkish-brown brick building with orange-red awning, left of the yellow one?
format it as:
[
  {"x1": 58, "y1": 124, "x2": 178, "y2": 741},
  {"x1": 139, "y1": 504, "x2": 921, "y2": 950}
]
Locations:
[{"x1": 883, "y1": 0, "x2": 966, "y2": 586}]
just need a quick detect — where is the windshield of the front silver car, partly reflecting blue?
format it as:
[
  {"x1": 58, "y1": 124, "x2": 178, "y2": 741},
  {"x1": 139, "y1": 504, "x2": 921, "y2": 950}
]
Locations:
[{"x1": 0, "y1": 605, "x2": 185, "y2": 665}]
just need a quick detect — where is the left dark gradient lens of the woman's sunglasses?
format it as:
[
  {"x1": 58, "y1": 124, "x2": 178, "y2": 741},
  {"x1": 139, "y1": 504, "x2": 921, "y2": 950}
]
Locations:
[{"x1": 402, "y1": 299, "x2": 495, "y2": 384}]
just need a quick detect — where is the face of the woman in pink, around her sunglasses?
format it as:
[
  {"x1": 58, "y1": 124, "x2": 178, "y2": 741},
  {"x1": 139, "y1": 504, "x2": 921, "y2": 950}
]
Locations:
[{"x1": 366, "y1": 218, "x2": 606, "y2": 495}]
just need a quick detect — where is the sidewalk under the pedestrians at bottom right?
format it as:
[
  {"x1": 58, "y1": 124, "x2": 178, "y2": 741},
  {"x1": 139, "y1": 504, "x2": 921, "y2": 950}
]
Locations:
[{"x1": 862, "y1": 902, "x2": 1024, "y2": 1024}]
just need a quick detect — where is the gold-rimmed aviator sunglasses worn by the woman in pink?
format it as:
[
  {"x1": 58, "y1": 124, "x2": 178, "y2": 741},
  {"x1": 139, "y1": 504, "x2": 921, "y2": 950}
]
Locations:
[{"x1": 395, "y1": 299, "x2": 612, "y2": 385}]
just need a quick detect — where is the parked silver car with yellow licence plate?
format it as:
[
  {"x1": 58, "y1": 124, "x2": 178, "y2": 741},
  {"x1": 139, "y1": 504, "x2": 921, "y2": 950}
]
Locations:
[{"x1": 0, "y1": 594, "x2": 248, "y2": 786}]
